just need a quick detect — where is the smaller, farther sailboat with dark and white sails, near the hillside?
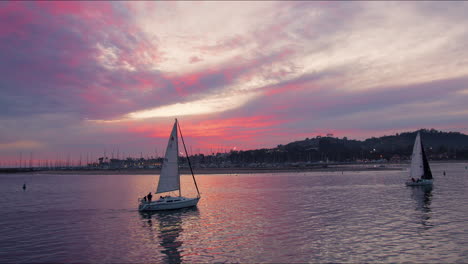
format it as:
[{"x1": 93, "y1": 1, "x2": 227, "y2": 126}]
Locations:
[{"x1": 406, "y1": 132, "x2": 433, "y2": 186}]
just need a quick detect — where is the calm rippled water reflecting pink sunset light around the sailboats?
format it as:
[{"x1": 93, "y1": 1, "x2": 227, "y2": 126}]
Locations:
[{"x1": 0, "y1": 163, "x2": 468, "y2": 263}]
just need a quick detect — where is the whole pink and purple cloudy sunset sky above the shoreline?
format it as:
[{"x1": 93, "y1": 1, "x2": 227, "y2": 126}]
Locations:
[{"x1": 0, "y1": 1, "x2": 468, "y2": 166}]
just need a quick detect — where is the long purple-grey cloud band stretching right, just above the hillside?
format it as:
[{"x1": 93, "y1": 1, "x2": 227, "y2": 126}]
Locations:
[{"x1": 227, "y1": 72, "x2": 468, "y2": 142}]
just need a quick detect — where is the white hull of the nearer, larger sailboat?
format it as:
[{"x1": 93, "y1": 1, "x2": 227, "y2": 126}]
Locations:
[{"x1": 138, "y1": 197, "x2": 200, "y2": 211}]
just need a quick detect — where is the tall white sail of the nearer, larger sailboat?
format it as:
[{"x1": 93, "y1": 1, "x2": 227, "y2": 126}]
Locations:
[{"x1": 156, "y1": 120, "x2": 180, "y2": 193}]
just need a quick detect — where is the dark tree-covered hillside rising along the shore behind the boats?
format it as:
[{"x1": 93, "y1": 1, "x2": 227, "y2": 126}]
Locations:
[{"x1": 188, "y1": 129, "x2": 468, "y2": 164}]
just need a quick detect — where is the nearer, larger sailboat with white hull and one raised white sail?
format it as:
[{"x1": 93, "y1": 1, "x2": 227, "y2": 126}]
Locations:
[{"x1": 138, "y1": 119, "x2": 200, "y2": 211}]
